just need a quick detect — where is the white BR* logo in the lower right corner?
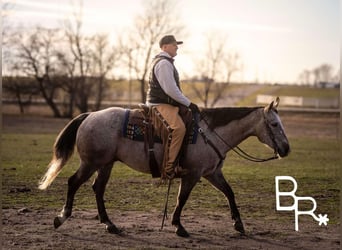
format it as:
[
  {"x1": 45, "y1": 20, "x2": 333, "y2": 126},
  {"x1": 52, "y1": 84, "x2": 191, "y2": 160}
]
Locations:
[{"x1": 275, "y1": 176, "x2": 329, "y2": 231}]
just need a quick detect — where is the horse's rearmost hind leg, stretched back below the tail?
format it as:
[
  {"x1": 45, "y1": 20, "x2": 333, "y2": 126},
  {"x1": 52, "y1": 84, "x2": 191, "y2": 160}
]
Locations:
[{"x1": 54, "y1": 163, "x2": 95, "y2": 228}]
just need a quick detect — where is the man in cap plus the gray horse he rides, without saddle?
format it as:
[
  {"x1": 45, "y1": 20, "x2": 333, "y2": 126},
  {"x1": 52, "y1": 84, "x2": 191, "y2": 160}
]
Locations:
[{"x1": 39, "y1": 33, "x2": 290, "y2": 237}]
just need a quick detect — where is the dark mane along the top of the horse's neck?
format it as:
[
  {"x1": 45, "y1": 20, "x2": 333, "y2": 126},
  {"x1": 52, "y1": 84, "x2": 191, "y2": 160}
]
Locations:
[{"x1": 201, "y1": 107, "x2": 260, "y2": 130}]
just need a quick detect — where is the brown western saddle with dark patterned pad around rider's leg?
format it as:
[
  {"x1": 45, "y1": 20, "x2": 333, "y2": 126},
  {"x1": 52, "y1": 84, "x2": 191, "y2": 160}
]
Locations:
[{"x1": 122, "y1": 104, "x2": 198, "y2": 178}]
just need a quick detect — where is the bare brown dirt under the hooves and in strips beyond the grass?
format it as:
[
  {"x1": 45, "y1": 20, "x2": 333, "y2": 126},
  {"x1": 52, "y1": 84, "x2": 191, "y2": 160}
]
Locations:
[{"x1": 2, "y1": 113, "x2": 340, "y2": 250}]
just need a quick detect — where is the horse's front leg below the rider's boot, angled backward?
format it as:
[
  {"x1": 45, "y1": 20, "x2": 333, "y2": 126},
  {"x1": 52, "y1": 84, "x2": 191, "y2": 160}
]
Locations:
[{"x1": 172, "y1": 174, "x2": 200, "y2": 237}]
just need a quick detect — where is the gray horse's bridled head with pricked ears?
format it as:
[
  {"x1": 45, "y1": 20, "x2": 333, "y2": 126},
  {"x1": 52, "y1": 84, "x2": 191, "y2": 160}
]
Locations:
[{"x1": 257, "y1": 97, "x2": 290, "y2": 157}]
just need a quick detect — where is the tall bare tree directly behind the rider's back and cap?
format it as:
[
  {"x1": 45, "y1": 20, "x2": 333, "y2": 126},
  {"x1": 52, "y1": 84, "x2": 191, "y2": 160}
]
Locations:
[{"x1": 125, "y1": 0, "x2": 184, "y2": 102}]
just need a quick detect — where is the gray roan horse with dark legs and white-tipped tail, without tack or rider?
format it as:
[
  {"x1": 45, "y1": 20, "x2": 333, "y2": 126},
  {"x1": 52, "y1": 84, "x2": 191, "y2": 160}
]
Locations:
[{"x1": 39, "y1": 98, "x2": 290, "y2": 237}]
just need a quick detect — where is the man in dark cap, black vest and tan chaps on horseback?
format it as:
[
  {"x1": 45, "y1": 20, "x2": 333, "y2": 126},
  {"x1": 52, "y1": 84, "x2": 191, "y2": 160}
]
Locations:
[{"x1": 146, "y1": 35, "x2": 199, "y2": 179}]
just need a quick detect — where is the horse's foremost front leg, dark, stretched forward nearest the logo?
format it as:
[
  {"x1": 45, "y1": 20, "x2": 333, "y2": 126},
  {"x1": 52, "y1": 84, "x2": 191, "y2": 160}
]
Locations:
[{"x1": 205, "y1": 169, "x2": 245, "y2": 234}]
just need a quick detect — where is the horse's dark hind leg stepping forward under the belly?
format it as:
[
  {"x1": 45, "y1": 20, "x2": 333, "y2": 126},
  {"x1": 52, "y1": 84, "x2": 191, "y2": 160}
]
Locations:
[{"x1": 93, "y1": 164, "x2": 121, "y2": 234}]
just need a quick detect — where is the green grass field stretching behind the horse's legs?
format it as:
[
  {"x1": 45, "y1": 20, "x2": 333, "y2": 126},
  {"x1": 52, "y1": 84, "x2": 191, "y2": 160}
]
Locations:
[{"x1": 2, "y1": 130, "x2": 340, "y2": 226}]
